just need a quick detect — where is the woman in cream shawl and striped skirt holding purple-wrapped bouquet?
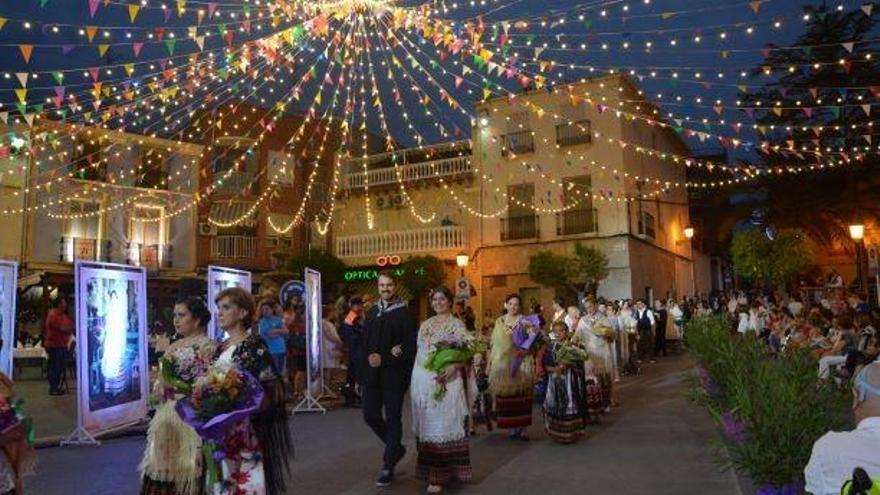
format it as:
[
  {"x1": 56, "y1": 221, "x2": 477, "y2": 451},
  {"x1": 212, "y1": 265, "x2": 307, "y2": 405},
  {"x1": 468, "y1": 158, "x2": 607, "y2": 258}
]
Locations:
[{"x1": 489, "y1": 294, "x2": 537, "y2": 440}]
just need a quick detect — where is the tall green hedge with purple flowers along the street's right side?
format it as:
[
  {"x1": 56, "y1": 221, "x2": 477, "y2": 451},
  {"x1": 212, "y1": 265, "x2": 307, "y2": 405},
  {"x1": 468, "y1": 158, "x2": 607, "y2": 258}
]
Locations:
[{"x1": 686, "y1": 316, "x2": 851, "y2": 489}]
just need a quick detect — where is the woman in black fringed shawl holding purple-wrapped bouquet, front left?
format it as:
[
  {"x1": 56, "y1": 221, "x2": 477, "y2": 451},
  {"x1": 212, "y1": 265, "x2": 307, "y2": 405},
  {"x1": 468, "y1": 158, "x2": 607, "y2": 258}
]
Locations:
[{"x1": 203, "y1": 287, "x2": 292, "y2": 495}]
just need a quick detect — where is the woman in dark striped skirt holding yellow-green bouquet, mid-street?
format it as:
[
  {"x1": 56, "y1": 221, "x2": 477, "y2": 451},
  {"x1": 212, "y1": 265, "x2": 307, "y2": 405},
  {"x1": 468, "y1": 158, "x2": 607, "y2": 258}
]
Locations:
[{"x1": 544, "y1": 321, "x2": 587, "y2": 444}]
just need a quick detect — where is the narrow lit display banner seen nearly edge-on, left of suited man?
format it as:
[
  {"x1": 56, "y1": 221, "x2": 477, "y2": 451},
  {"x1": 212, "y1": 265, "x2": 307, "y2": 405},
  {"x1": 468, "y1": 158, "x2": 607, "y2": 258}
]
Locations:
[{"x1": 290, "y1": 268, "x2": 329, "y2": 414}]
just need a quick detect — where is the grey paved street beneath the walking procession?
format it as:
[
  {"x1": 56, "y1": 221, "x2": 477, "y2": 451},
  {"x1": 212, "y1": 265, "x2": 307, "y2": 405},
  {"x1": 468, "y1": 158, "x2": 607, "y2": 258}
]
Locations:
[{"x1": 28, "y1": 356, "x2": 740, "y2": 495}]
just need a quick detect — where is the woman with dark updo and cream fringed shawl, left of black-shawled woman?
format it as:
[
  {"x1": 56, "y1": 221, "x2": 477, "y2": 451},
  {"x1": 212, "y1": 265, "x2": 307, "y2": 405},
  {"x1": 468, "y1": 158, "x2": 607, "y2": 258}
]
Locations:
[{"x1": 140, "y1": 297, "x2": 216, "y2": 495}]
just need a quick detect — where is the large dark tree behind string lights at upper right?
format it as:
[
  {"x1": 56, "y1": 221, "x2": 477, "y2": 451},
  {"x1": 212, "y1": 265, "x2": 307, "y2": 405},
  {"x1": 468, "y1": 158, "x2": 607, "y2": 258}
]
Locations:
[{"x1": 739, "y1": 4, "x2": 880, "y2": 248}]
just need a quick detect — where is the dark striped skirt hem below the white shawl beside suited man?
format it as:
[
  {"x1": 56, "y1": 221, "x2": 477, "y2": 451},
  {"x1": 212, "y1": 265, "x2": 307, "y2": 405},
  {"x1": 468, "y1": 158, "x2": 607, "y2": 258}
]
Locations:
[{"x1": 416, "y1": 438, "x2": 473, "y2": 485}]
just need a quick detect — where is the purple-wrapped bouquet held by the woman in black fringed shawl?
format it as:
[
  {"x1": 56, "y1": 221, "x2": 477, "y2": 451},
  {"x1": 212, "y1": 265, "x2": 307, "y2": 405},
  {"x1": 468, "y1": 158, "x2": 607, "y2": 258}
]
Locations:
[{"x1": 176, "y1": 367, "x2": 264, "y2": 486}]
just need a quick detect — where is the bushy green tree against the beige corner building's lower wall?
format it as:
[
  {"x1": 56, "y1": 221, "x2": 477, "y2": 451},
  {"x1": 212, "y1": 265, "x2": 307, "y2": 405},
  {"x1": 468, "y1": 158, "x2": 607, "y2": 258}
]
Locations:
[{"x1": 529, "y1": 243, "x2": 608, "y2": 297}]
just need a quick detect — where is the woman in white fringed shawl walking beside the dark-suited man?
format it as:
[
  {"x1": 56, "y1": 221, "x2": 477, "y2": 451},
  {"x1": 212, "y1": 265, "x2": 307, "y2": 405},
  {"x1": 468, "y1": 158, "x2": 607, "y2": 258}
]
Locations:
[{"x1": 410, "y1": 287, "x2": 477, "y2": 493}]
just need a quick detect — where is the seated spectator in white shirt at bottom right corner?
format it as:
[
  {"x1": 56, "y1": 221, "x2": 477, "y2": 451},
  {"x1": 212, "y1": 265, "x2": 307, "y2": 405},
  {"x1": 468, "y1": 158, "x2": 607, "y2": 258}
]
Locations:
[{"x1": 804, "y1": 362, "x2": 880, "y2": 495}]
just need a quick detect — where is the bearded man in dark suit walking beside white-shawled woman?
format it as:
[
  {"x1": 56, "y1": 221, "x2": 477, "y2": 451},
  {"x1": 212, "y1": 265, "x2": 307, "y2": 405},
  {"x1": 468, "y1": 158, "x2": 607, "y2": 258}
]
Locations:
[{"x1": 358, "y1": 272, "x2": 419, "y2": 486}]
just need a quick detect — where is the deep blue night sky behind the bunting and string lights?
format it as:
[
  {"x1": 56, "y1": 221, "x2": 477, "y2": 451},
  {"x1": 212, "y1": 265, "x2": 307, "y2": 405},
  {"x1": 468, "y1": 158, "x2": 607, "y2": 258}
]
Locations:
[{"x1": 0, "y1": 0, "x2": 844, "y2": 157}]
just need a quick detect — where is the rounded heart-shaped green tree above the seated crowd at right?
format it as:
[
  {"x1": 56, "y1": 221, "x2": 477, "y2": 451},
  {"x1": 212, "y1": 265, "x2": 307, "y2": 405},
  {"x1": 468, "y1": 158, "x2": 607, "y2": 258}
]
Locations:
[{"x1": 730, "y1": 229, "x2": 812, "y2": 285}]
